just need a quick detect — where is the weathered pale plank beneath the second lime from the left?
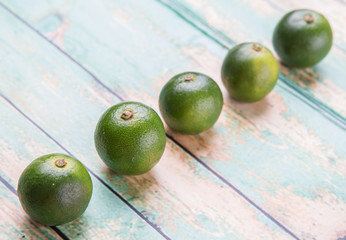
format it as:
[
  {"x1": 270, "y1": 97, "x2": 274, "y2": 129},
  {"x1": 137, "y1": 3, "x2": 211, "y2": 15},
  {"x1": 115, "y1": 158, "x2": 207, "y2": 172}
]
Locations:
[{"x1": 0, "y1": 6, "x2": 292, "y2": 239}]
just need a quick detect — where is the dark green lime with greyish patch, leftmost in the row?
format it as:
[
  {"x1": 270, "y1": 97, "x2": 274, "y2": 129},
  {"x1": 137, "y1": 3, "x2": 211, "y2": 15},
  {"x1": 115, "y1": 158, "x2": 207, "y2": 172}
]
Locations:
[{"x1": 17, "y1": 153, "x2": 92, "y2": 226}]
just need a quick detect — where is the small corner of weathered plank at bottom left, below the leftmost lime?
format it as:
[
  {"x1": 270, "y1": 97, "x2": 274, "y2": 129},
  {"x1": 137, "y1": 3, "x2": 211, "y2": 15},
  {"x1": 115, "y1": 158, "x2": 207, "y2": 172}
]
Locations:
[{"x1": 0, "y1": 182, "x2": 61, "y2": 240}]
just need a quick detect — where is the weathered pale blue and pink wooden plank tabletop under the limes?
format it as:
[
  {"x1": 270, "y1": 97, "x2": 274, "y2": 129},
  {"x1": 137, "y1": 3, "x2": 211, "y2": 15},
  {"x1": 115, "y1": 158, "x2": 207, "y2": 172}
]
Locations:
[{"x1": 0, "y1": 0, "x2": 346, "y2": 240}]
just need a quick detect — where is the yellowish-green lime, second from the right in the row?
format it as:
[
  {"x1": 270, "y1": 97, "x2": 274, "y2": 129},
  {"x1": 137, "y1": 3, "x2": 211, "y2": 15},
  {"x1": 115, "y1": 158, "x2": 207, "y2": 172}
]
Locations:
[{"x1": 221, "y1": 42, "x2": 279, "y2": 102}]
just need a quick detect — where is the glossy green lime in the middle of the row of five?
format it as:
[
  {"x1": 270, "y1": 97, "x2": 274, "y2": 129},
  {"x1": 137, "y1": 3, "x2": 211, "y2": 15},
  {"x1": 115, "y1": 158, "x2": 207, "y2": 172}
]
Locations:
[{"x1": 159, "y1": 72, "x2": 223, "y2": 134}]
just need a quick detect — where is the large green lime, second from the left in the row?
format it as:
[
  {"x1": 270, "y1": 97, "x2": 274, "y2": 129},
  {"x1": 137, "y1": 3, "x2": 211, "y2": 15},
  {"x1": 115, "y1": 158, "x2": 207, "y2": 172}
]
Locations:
[{"x1": 94, "y1": 102, "x2": 166, "y2": 175}]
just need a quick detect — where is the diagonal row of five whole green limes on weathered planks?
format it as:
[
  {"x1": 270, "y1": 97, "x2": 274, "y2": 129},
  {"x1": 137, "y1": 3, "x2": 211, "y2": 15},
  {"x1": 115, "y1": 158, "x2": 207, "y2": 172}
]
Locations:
[{"x1": 18, "y1": 10, "x2": 332, "y2": 225}]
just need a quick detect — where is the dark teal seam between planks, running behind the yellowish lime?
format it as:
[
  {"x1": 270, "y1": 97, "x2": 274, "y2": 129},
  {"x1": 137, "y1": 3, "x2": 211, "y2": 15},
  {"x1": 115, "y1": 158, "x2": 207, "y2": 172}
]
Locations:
[{"x1": 156, "y1": 0, "x2": 346, "y2": 130}]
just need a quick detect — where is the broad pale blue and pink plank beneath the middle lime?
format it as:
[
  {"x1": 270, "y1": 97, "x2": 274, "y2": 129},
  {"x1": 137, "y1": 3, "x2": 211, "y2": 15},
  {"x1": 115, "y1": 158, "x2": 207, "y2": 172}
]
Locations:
[{"x1": 0, "y1": 1, "x2": 346, "y2": 238}]
